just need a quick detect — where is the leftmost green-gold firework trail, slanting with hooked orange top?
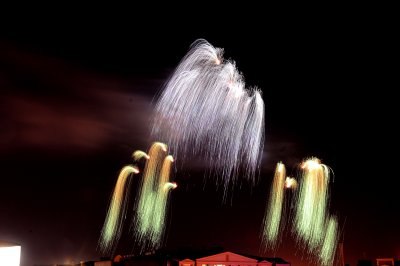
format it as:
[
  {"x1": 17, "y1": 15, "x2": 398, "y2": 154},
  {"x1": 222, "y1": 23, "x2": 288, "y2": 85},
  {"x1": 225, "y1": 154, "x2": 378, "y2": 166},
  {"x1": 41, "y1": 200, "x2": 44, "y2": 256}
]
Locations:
[{"x1": 99, "y1": 165, "x2": 139, "y2": 253}]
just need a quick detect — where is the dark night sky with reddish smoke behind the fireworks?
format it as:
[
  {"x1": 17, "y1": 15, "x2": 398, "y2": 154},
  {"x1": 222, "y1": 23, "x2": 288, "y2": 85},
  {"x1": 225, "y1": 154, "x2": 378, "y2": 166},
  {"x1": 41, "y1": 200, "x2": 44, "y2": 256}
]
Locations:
[{"x1": 0, "y1": 8, "x2": 400, "y2": 266}]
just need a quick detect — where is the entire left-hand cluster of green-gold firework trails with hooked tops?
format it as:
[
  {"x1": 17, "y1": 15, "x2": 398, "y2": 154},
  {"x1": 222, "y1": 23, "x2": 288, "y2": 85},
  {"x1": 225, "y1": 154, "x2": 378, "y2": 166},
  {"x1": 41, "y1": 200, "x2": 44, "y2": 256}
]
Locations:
[{"x1": 99, "y1": 142, "x2": 177, "y2": 254}]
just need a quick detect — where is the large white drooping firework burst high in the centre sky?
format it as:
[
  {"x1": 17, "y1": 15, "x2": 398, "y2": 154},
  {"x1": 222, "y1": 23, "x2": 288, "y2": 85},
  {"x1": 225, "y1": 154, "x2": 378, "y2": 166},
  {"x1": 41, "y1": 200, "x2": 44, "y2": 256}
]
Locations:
[{"x1": 151, "y1": 39, "x2": 264, "y2": 194}]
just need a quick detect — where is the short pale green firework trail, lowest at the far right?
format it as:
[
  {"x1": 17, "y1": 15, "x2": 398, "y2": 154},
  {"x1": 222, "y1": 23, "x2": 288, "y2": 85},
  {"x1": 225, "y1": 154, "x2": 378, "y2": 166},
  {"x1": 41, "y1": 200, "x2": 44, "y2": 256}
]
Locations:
[{"x1": 319, "y1": 216, "x2": 339, "y2": 266}]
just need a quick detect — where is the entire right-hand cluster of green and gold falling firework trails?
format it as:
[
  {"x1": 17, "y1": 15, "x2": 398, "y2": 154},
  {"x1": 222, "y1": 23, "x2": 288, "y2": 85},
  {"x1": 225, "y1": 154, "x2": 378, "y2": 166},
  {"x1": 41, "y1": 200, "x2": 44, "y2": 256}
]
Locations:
[{"x1": 261, "y1": 157, "x2": 339, "y2": 266}]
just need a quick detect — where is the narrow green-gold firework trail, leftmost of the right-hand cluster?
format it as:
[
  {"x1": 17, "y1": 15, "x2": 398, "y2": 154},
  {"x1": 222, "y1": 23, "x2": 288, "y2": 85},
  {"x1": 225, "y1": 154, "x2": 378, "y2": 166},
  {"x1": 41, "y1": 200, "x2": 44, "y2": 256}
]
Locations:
[{"x1": 262, "y1": 162, "x2": 286, "y2": 249}]
